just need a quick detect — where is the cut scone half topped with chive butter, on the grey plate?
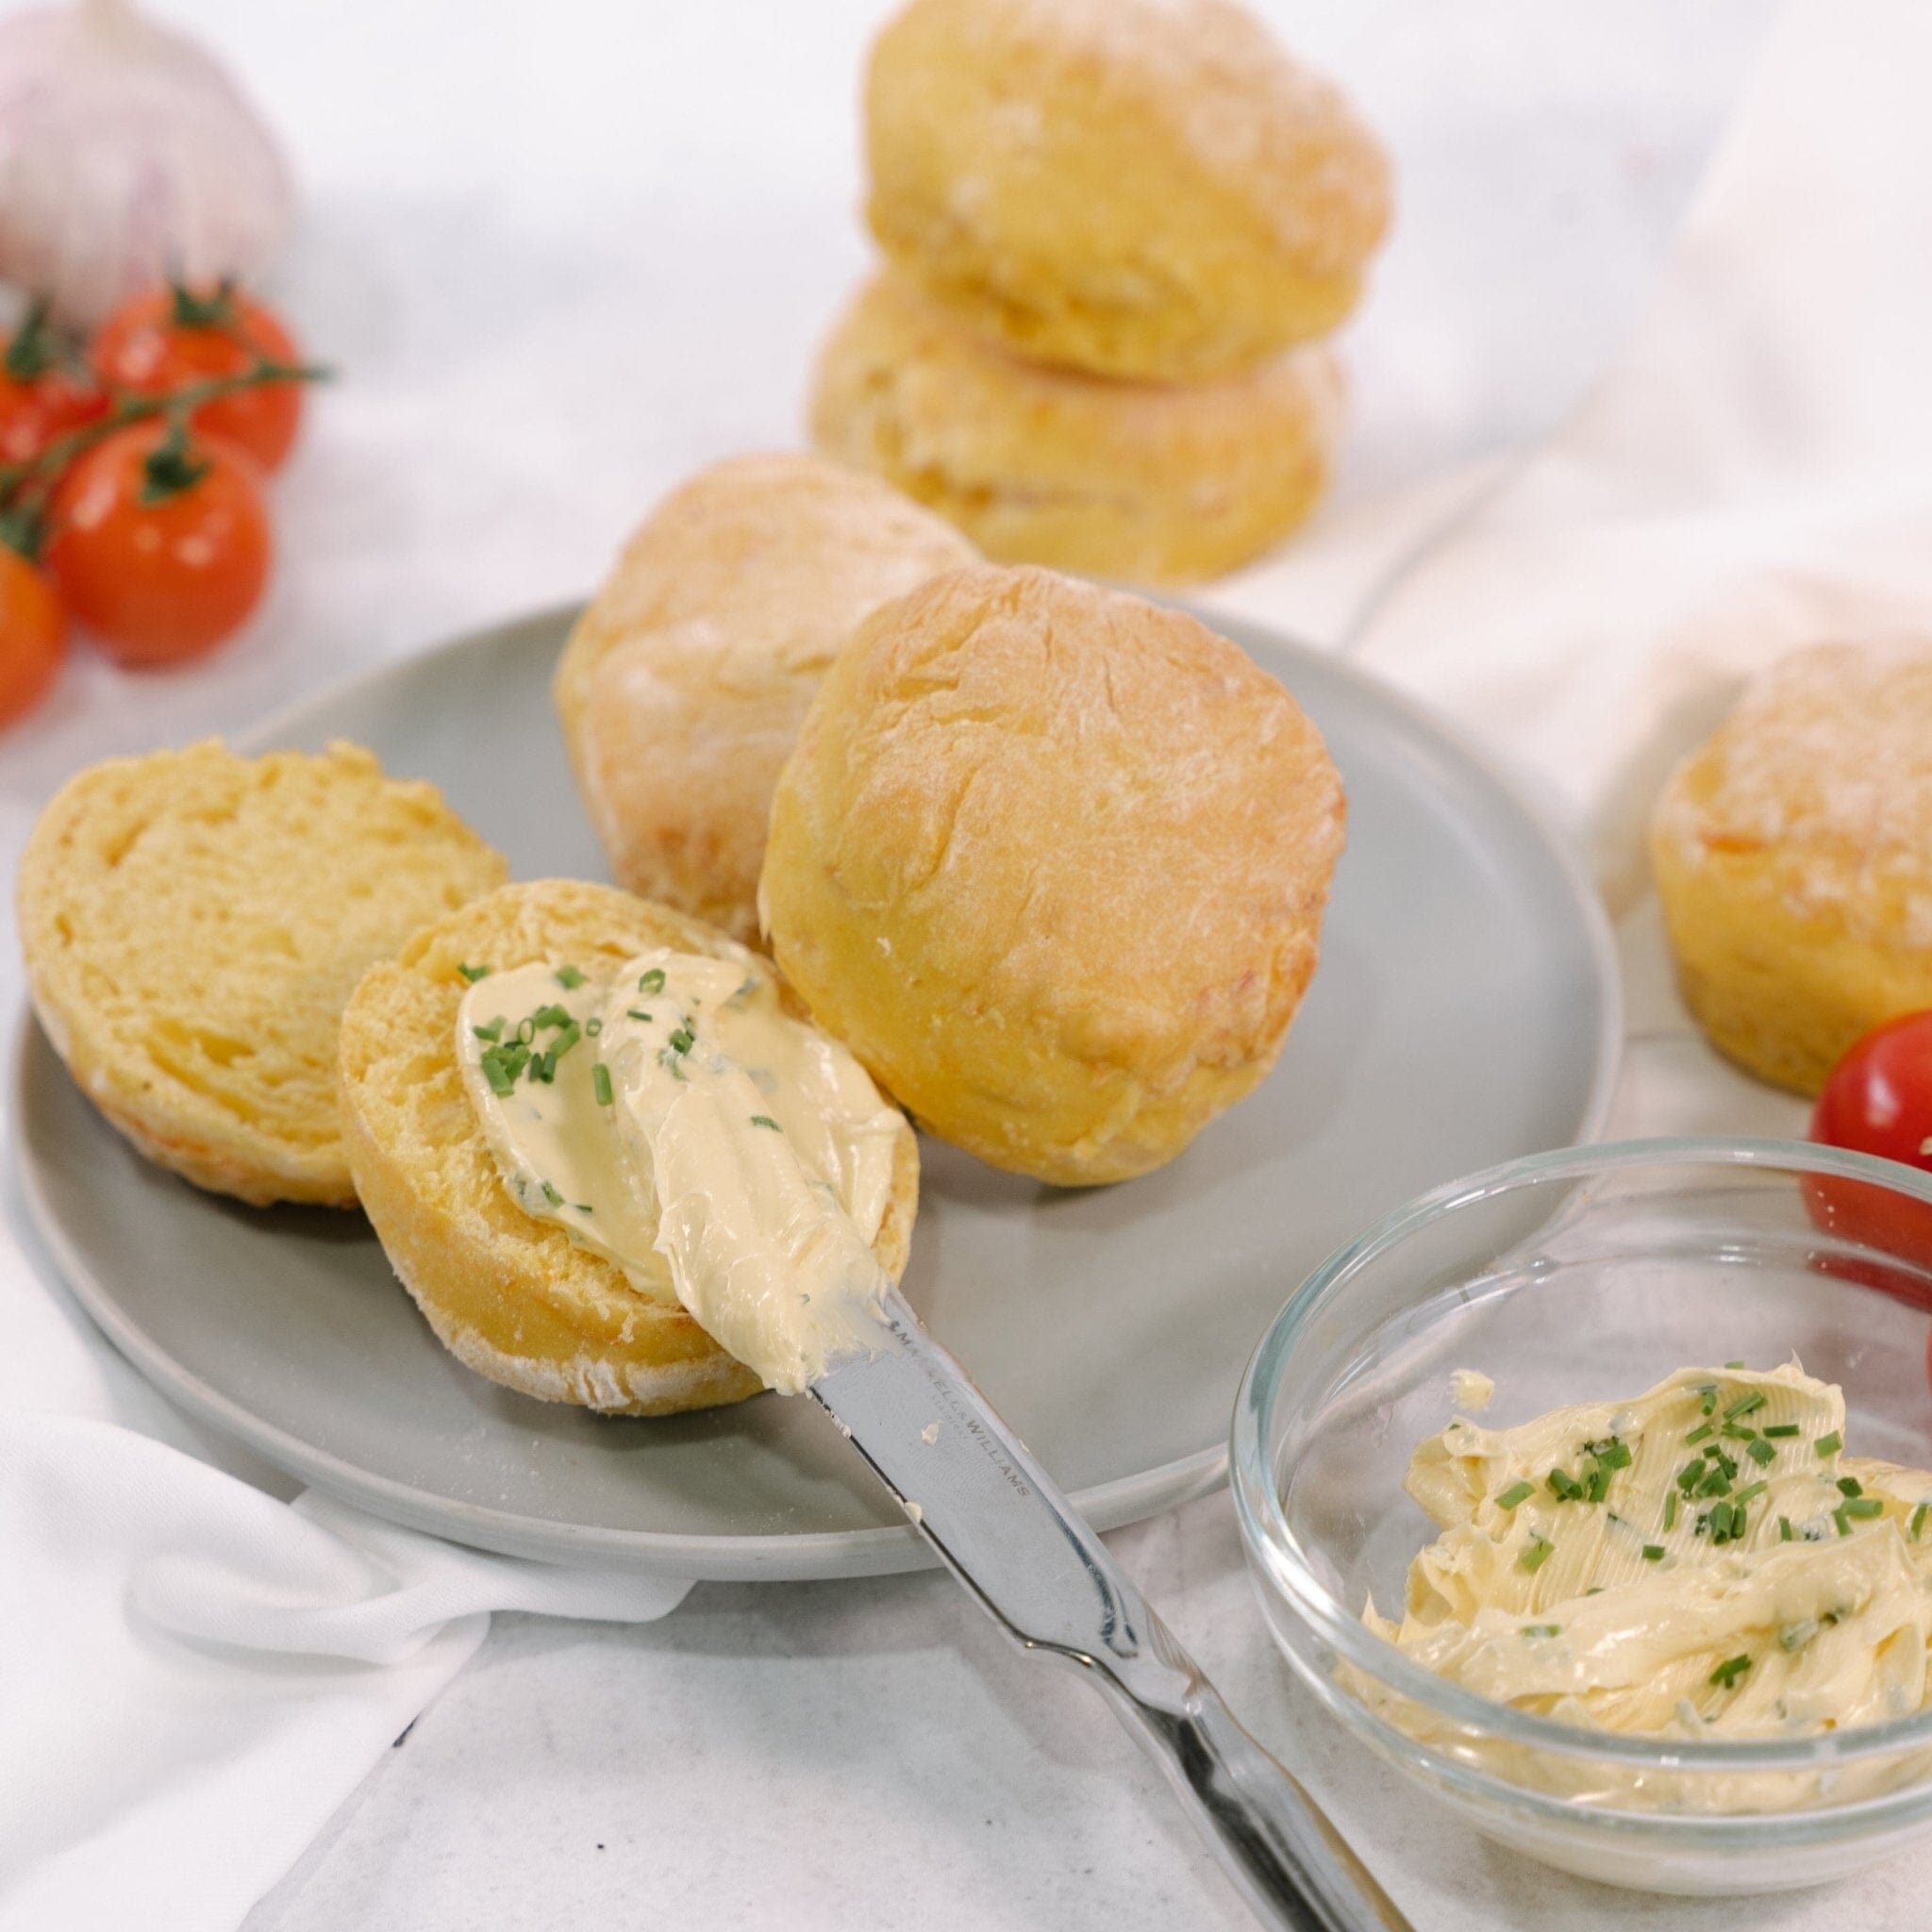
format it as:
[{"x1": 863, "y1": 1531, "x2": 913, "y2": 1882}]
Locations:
[{"x1": 341, "y1": 879, "x2": 920, "y2": 1416}]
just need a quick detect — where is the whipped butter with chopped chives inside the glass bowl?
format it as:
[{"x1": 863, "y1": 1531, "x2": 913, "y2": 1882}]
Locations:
[{"x1": 1364, "y1": 1362, "x2": 1932, "y2": 1761}]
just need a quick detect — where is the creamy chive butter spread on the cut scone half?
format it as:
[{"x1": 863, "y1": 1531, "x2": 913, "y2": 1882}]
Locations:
[{"x1": 456, "y1": 947, "x2": 904, "y2": 1395}]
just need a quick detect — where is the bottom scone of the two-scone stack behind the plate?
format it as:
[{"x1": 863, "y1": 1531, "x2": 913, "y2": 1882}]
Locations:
[{"x1": 811, "y1": 273, "x2": 1341, "y2": 583}]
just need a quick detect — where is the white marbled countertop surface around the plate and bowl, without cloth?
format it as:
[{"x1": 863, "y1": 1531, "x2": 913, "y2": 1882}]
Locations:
[{"x1": 0, "y1": 0, "x2": 1855, "y2": 1932}]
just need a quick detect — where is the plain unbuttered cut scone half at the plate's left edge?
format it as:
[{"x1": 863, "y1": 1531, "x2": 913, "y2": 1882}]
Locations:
[{"x1": 19, "y1": 740, "x2": 505, "y2": 1208}]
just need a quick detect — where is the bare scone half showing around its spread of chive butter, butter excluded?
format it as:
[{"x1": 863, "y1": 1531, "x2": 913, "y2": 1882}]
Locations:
[{"x1": 341, "y1": 879, "x2": 920, "y2": 1416}]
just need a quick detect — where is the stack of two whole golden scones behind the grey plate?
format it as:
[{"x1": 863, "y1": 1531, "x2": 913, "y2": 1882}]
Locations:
[{"x1": 811, "y1": 0, "x2": 1390, "y2": 583}]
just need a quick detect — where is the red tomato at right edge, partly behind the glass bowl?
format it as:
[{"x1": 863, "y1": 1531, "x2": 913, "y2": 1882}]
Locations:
[{"x1": 1805, "y1": 1012, "x2": 1932, "y2": 1302}]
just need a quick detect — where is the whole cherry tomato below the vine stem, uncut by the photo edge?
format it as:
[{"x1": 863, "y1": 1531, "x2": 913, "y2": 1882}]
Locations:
[{"x1": 46, "y1": 424, "x2": 275, "y2": 665}]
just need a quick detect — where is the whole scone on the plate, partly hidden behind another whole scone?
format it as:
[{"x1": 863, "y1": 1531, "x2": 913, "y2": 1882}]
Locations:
[{"x1": 555, "y1": 456, "x2": 974, "y2": 941}]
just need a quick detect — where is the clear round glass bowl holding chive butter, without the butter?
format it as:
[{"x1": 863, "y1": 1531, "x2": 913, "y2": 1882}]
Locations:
[{"x1": 1233, "y1": 1140, "x2": 1932, "y2": 1893}]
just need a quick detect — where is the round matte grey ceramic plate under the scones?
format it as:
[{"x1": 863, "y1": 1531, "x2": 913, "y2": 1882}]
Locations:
[{"x1": 17, "y1": 610, "x2": 1617, "y2": 1576}]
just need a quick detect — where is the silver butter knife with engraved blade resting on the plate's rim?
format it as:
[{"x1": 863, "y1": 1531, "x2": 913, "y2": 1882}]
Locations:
[{"x1": 811, "y1": 1292, "x2": 1414, "y2": 1932}]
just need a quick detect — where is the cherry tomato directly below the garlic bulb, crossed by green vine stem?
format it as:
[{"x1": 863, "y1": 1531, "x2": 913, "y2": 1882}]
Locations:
[{"x1": 89, "y1": 282, "x2": 301, "y2": 470}]
